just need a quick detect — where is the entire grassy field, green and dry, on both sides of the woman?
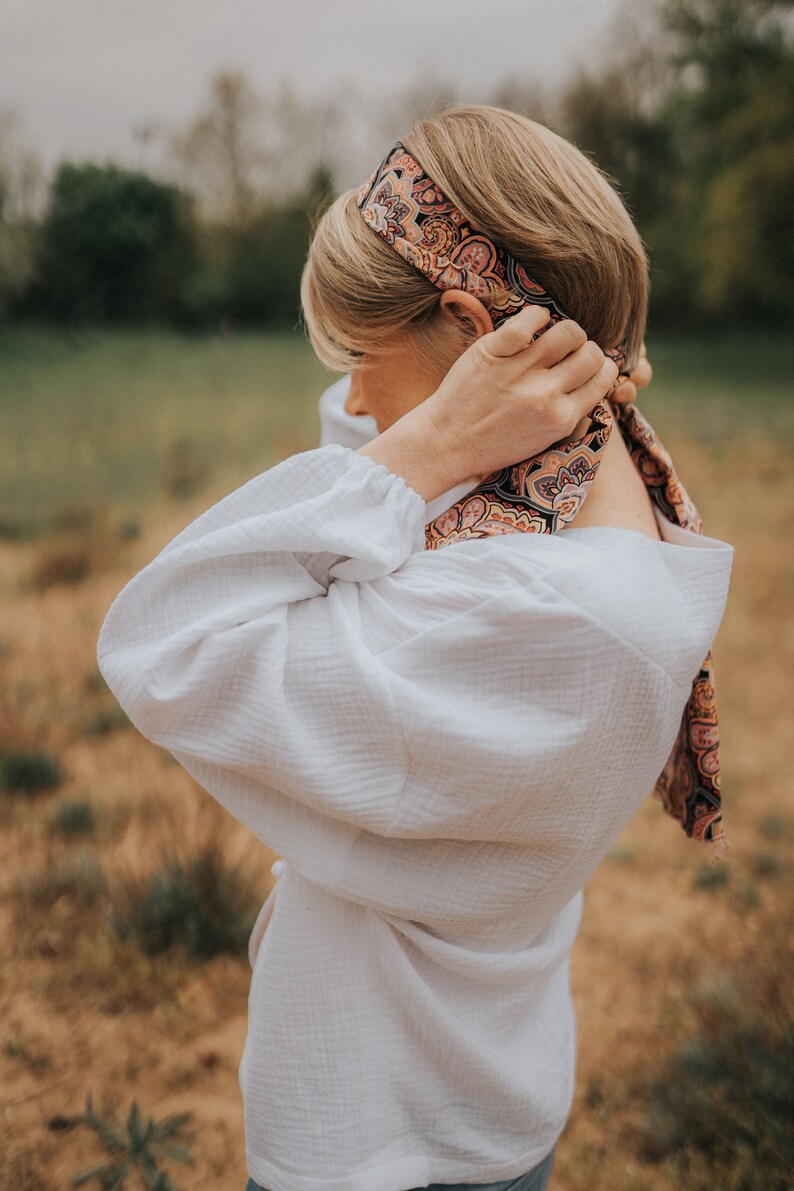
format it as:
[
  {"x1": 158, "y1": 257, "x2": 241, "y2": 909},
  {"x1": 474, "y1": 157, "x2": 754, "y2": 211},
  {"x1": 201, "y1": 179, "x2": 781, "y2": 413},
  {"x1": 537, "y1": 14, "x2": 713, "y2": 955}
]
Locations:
[{"x1": 0, "y1": 331, "x2": 794, "y2": 1191}]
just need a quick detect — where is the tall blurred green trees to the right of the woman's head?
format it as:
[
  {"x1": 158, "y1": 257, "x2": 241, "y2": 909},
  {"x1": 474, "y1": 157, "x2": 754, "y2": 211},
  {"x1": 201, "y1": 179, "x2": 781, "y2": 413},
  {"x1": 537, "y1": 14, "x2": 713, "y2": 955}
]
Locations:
[{"x1": 561, "y1": 0, "x2": 794, "y2": 326}]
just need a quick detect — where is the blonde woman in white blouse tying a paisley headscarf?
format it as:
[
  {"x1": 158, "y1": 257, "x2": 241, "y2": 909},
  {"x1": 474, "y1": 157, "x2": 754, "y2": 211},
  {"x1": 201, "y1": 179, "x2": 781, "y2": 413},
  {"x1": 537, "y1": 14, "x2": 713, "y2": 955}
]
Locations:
[{"x1": 99, "y1": 107, "x2": 732, "y2": 1191}]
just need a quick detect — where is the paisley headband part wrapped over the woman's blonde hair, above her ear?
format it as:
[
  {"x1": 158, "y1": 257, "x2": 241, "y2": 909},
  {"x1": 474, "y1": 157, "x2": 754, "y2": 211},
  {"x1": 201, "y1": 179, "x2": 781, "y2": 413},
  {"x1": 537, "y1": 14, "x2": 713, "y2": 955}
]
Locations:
[{"x1": 357, "y1": 142, "x2": 625, "y2": 369}]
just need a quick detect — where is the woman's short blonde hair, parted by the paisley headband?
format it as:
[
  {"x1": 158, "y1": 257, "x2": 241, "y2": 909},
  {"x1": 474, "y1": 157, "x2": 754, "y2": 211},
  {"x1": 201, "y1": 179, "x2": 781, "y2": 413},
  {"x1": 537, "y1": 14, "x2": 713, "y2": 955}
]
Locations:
[{"x1": 301, "y1": 106, "x2": 649, "y2": 372}]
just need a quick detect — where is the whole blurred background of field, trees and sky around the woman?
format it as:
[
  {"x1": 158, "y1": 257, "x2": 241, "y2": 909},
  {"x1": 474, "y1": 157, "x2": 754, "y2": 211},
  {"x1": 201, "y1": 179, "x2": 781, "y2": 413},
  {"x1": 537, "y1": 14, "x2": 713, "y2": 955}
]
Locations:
[{"x1": 0, "y1": 0, "x2": 794, "y2": 1191}]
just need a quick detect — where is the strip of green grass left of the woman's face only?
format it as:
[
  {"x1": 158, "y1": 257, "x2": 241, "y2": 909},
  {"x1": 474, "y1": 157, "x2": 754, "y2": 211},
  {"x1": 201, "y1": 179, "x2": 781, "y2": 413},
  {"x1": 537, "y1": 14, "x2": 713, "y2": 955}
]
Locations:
[{"x1": 0, "y1": 328, "x2": 330, "y2": 536}]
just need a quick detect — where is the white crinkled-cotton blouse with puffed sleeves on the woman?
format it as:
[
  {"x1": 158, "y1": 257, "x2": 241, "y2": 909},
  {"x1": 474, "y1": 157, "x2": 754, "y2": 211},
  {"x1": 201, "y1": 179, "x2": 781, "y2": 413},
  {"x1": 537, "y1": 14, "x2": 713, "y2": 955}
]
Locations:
[{"x1": 99, "y1": 373, "x2": 732, "y2": 1191}]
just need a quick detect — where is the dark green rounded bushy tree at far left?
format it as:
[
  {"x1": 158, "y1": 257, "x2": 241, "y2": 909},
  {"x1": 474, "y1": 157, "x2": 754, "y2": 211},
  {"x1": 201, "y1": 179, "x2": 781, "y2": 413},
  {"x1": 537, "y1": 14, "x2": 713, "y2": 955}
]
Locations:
[{"x1": 31, "y1": 163, "x2": 195, "y2": 322}]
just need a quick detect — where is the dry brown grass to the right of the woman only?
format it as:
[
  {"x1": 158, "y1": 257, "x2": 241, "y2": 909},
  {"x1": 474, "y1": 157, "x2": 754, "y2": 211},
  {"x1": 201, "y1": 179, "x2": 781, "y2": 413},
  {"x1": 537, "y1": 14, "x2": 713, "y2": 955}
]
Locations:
[{"x1": 552, "y1": 414, "x2": 794, "y2": 1191}]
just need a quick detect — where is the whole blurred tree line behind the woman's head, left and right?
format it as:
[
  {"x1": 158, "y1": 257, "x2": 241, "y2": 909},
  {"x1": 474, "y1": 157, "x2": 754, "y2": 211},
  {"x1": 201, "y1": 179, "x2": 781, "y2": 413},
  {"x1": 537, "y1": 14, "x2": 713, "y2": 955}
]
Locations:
[{"x1": 0, "y1": 0, "x2": 794, "y2": 329}]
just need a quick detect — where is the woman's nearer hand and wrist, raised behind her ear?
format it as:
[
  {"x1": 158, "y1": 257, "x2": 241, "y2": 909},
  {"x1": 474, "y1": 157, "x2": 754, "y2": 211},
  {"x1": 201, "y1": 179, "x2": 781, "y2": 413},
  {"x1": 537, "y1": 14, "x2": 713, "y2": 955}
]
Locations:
[{"x1": 360, "y1": 306, "x2": 618, "y2": 500}]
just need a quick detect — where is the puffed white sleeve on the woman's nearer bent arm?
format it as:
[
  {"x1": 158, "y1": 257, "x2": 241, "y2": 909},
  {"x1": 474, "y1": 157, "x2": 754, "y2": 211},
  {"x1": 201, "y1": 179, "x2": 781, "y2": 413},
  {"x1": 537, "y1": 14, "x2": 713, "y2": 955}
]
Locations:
[{"x1": 98, "y1": 445, "x2": 425, "y2": 880}]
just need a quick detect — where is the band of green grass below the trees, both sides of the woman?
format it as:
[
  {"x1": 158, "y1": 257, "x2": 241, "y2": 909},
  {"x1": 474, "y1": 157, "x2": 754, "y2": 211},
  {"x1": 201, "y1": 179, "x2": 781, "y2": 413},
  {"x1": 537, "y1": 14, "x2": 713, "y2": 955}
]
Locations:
[{"x1": 0, "y1": 328, "x2": 794, "y2": 536}]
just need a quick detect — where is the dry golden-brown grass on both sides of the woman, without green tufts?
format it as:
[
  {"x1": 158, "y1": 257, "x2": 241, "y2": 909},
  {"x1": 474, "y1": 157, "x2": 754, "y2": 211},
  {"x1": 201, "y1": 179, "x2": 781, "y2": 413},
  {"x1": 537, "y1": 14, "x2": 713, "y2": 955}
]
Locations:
[{"x1": 0, "y1": 328, "x2": 794, "y2": 1191}]
